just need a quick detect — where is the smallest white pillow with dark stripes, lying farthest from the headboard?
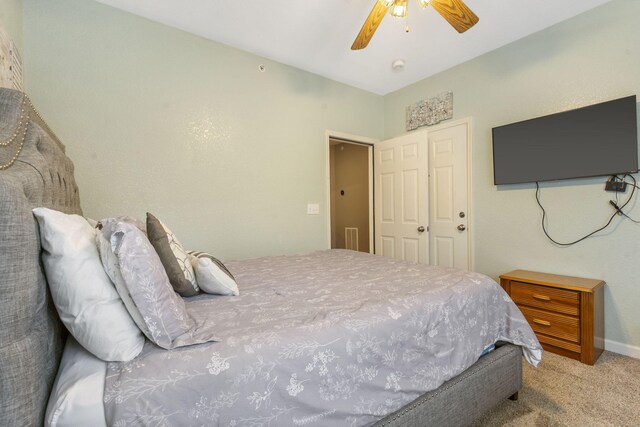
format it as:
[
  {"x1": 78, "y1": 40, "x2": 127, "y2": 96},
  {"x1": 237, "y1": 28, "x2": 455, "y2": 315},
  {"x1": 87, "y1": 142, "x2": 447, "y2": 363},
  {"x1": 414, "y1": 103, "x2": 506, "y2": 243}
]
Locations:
[{"x1": 188, "y1": 251, "x2": 240, "y2": 295}]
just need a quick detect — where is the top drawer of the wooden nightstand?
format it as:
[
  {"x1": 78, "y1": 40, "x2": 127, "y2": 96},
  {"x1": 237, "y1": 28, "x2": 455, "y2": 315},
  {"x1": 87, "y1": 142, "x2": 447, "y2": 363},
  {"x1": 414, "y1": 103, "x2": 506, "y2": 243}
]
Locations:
[{"x1": 511, "y1": 281, "x2": 580, "y2": 316}]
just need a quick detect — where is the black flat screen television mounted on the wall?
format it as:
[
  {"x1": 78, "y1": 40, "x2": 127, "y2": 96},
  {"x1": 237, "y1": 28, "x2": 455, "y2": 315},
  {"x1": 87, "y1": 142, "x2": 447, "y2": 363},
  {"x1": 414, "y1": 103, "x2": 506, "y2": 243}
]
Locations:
[{"x1": 493, "y1": 95, "x2": 638, "y2": 185}]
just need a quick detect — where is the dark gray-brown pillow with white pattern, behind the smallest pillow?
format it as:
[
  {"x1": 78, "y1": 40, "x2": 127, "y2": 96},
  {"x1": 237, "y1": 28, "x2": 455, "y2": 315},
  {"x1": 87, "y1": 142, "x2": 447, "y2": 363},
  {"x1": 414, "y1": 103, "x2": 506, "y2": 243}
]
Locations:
[{"x1": 147, "y1": 212, "x2": 200, "y2": 297}]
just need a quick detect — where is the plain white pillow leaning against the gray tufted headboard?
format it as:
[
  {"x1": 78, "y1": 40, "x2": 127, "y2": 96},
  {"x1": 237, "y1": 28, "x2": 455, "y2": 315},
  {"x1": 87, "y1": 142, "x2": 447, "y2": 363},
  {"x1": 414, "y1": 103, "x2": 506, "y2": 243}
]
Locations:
[{"x1": 33, "y1": 208, "x2": 144, "y2": 361}]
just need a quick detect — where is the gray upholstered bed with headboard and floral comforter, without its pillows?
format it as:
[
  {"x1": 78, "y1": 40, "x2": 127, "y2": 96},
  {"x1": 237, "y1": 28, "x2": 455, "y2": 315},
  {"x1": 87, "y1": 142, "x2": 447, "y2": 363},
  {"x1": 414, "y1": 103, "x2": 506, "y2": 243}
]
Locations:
[{"x1": 0, "y1": 89, "x2": 541, "y2": 426}]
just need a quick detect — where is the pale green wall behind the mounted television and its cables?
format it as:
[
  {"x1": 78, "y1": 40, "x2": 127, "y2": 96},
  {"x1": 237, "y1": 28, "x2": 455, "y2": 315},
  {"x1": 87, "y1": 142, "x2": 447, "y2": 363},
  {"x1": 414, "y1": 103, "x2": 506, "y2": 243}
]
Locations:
[{"x1": 385, "y1": 1, "x2": 640, "y2": 346}]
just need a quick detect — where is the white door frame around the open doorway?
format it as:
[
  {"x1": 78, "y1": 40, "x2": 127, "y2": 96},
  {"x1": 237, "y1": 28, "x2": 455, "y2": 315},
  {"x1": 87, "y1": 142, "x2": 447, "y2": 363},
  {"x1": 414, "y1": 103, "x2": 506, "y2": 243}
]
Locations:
[{"x1": 324, "y1": 130, "x2": 378, "y2": 254}]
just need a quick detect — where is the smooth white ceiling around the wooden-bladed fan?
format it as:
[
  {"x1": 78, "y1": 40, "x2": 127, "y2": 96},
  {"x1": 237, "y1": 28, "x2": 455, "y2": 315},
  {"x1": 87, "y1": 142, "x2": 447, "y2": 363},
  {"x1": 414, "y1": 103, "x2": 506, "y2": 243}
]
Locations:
[{"x1": 98, "y1": 0, "x2": 609, "y2": 95}]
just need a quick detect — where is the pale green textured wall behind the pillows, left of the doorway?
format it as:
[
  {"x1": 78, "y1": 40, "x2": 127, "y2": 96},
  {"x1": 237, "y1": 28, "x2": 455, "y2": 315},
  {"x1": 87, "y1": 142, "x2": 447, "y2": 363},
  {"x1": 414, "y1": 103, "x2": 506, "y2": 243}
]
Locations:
[{"x1": 24, "y1": 0, "x2": 383, "y2": 259}]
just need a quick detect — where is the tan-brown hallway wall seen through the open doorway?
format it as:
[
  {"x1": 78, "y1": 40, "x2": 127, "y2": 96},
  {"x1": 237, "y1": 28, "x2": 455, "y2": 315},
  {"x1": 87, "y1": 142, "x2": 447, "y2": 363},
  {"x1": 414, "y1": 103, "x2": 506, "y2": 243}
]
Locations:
[{"x1": 331, "y1": 143, "x2": 369, "y2": 252}]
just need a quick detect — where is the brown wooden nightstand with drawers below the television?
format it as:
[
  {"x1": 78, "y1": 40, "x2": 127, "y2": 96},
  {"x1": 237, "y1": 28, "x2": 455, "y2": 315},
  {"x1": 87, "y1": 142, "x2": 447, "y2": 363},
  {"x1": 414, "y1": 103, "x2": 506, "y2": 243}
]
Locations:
[{"x1": 500, "y1": 270, "x2": 605, "y2": 365}]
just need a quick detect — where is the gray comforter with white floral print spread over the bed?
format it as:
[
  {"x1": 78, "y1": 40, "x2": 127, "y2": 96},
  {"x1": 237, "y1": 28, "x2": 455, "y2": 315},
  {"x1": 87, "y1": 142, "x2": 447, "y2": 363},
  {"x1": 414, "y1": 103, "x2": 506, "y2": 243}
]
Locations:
[{"x1": 104, "y1": 250, "x2": 542, "y2": 427}]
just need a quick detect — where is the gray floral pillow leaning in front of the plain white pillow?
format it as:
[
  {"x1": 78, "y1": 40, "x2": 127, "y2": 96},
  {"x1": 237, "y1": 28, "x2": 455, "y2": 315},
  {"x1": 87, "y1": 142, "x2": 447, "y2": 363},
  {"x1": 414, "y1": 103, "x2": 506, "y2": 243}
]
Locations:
[{"x1": 100, "y1": 219, "x2": 213, "y2": 349}]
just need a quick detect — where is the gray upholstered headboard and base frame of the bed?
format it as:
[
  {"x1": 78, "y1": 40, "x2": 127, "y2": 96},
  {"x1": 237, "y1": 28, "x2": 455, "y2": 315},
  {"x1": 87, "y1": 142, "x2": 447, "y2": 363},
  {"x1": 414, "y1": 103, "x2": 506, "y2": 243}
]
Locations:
[{"x1": 0, "y1": 88, "x2": 522, "y2": 427}]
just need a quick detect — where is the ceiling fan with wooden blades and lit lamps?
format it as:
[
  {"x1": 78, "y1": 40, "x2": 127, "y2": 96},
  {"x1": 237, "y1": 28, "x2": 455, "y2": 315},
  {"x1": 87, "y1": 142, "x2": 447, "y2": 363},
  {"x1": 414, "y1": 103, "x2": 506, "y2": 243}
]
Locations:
[{"x1": 351, "y1": 0, "x2": 479, "y2": 50}]
